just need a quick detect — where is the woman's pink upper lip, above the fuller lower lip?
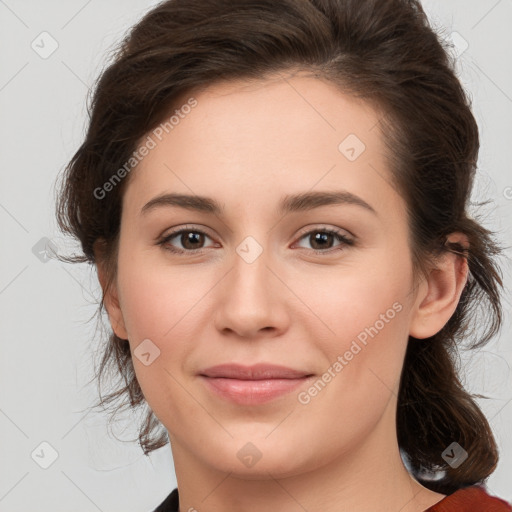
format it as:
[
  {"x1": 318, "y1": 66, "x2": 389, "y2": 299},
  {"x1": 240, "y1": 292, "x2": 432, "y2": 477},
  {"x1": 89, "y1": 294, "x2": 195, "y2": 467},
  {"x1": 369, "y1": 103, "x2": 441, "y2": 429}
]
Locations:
[{"x1": 199, "y1": 363, "x2": 312, "y2": 380}]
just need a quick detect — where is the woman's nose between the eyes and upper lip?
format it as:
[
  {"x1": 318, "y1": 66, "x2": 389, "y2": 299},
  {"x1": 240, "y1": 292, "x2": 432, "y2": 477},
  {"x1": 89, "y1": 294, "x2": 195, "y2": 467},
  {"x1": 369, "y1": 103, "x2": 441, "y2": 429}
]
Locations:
[{"x1": 215, "y1": 243, "x2": 292, "y2": 340}]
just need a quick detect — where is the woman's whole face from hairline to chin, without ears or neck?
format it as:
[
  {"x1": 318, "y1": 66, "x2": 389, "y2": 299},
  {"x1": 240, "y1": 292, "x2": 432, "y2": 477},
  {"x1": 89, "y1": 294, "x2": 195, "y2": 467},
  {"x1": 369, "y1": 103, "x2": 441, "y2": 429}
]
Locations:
[{"x1": 109, "y1": 75, "x2": 428, "y2": 478}]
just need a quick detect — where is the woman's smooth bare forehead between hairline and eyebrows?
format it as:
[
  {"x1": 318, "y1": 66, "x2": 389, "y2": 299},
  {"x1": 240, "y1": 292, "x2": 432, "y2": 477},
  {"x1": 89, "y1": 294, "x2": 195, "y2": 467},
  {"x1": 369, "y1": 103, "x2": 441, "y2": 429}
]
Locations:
[{"x1": 124, "y1": 71, "x2": 396, "y2": 222}]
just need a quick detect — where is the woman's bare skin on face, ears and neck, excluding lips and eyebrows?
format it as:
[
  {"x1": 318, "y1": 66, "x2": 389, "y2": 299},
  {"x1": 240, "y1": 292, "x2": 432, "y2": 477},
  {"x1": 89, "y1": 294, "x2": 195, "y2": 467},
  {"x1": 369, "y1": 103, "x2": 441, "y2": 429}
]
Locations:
[{"x1": 98, "y1": 74, "x2": 467, "y2": 512}]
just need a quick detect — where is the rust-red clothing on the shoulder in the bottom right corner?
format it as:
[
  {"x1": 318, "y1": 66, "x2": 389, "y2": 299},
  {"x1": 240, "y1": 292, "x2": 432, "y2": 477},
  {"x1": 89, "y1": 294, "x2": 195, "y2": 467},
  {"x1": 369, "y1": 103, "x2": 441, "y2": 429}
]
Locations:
[{"x1": 425, "y1": 486, "x2": 512, "y2": 512}]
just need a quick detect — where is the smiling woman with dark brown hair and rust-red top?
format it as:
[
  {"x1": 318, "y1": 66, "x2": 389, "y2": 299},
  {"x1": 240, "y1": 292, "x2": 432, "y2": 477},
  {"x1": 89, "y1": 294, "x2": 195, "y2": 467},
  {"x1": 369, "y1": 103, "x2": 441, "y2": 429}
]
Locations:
[{"x1": 54, "y1": 0, "x2": 512, "y2": 512}]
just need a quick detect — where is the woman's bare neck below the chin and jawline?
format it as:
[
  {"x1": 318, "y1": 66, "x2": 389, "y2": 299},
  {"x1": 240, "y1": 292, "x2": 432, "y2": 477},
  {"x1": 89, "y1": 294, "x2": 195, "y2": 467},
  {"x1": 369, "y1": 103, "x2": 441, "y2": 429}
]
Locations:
[{"x1": 172, "y1": 408, "x2": 444, "y2": 512}]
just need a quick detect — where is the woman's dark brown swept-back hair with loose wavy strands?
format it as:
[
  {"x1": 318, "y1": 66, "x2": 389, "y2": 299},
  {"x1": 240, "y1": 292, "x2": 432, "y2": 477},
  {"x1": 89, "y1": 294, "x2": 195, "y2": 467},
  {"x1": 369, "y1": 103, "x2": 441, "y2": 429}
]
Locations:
[{"x1": 57, "y1": 0, "x2": 503, "y2": 494}]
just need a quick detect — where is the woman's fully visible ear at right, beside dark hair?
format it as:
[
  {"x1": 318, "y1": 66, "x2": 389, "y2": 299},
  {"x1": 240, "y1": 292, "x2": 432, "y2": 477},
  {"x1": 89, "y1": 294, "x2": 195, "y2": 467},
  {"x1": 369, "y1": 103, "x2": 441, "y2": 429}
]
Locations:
[{"x1": 409, "y1": 233, "x2": 469, "y2": 339}]
